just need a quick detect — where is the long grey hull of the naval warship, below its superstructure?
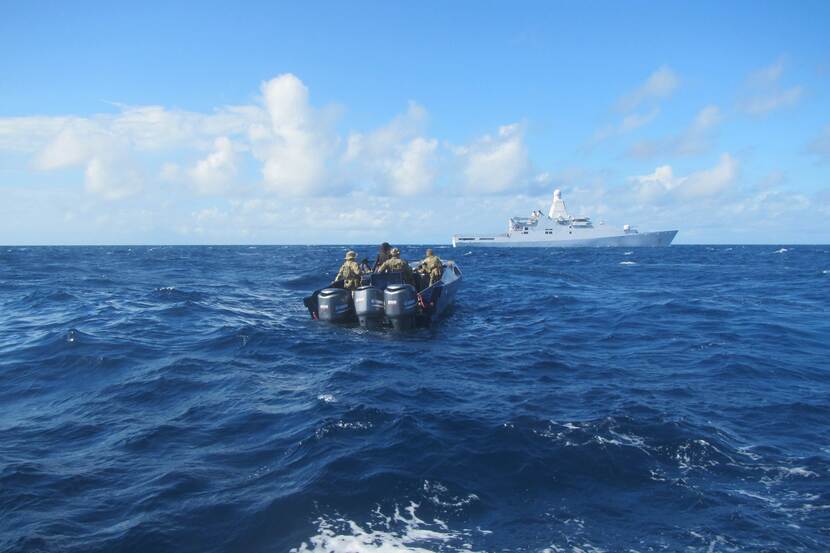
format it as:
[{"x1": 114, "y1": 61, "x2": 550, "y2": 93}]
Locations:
[{"x1": 452, "y1": 230, "x2": 677, "y2": 248}]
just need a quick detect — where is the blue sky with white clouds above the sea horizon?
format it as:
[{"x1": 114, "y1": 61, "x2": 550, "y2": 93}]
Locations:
[{"x1": 0, "y1": 1, "x2": 830, "y2": 244}]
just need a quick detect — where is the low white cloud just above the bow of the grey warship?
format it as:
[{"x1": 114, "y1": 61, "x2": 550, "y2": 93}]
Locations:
[{"x1": 629, "y1": 153, "x2": 738, "y2": 202}]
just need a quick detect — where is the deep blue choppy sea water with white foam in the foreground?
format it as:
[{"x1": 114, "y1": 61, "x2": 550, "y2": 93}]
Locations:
[{"x1": 0, "y1": 246, "x2": 830, "y2": 553}]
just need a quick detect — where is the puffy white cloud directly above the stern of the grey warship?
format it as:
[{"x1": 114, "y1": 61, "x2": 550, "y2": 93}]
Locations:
[{"x1": 456, "y1": 124, "x2": 531, "y2": 193}]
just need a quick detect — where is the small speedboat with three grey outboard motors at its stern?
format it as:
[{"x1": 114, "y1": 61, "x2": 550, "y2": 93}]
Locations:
[{"x1": 303, "y1": 261, "x2": 461, "y2": 330}]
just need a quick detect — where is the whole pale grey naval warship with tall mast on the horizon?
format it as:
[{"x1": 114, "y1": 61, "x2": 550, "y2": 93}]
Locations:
[{"x1": 452, "y1": 190, "x2": 677, "y2": 248}]
